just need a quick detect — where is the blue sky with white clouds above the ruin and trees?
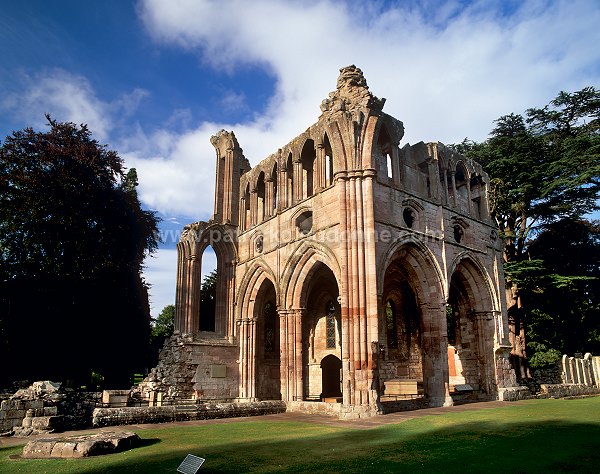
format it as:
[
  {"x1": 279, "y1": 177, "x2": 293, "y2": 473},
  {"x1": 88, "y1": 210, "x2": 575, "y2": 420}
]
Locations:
[{"x1": 0, "y1": 0, "x2": 600, "y2": 315}]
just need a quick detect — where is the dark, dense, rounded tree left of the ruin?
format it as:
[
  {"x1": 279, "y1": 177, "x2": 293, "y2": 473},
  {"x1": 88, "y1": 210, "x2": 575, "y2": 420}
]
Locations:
[{"x1": 0, "y1": 117, "x2": 157, "y2": 385}]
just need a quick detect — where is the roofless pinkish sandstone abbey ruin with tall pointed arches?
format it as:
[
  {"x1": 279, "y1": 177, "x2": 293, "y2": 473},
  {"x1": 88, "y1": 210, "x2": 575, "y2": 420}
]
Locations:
[{"x1": 137, "y1": 66, "x2": 516, "y2": 417}]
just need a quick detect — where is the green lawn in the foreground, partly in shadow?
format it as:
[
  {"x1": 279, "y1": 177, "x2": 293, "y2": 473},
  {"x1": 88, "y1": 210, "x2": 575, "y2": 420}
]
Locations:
[{"x1": 0, "y1": 397, "x2": 600, "y2": 474}]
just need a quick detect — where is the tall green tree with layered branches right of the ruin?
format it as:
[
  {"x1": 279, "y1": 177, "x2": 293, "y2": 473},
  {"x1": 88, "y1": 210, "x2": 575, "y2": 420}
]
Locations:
[{"x1": 457, "y1": 87, "x2": 600, "y2": 376}]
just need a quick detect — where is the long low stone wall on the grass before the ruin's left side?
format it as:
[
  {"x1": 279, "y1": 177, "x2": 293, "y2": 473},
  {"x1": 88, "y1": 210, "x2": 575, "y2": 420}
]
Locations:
[{"x1": 92, "y1": 401, "x2": 286, "y2": 427}]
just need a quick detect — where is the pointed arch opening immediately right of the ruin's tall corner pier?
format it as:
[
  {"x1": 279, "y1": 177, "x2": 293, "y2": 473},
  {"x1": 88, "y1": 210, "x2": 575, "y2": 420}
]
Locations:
[{"x1": 378, "y1": 243, "x2": 451, "y2": 407}]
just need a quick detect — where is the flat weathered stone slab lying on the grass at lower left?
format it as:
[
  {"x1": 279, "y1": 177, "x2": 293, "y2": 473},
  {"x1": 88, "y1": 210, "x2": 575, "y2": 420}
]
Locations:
[{"x1": 23, "y1": 431, "x2": 140, "y2": 458}]
